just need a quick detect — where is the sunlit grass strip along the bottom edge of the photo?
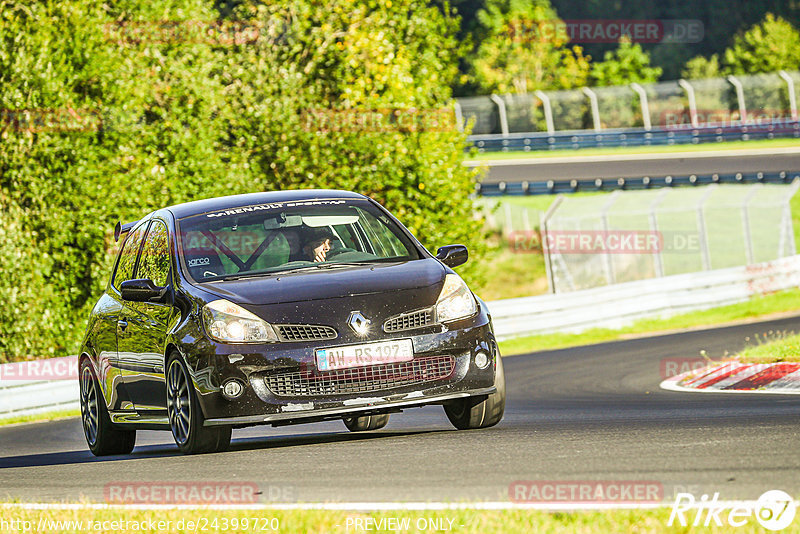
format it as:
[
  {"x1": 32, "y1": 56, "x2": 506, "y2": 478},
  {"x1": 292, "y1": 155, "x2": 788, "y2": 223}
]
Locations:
[{"x1": 0, "y1": 506, "x2": 800, "y2": 534}]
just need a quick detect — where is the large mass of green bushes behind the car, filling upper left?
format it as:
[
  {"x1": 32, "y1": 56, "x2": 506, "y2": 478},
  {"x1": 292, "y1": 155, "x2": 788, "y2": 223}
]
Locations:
[{"x1": 0, "y1": 0, "x2": 484, "y2": 361}]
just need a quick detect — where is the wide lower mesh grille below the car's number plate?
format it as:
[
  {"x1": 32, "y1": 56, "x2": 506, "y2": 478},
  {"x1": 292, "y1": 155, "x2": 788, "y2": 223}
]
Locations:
[{"x1": 266, "y1": 355, "x2": 456, "y2": 397}]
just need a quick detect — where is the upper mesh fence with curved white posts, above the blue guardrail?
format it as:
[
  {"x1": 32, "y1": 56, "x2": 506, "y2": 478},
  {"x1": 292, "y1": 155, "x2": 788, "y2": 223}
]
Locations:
[{"x1": 456, "y1": 71, "x2": 800, "y2": 135}]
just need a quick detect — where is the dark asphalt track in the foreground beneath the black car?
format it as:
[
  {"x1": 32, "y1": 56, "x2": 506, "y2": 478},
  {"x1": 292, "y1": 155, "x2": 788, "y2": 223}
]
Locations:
[{"x1": 0, "y1": 317, "x2": 800, "y2": 502}]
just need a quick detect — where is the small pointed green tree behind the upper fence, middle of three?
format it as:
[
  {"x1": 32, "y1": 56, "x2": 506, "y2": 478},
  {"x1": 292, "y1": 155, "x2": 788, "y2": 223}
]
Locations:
[{"x1": 591, "y1": 37, "x2": 662, "y2": 86}]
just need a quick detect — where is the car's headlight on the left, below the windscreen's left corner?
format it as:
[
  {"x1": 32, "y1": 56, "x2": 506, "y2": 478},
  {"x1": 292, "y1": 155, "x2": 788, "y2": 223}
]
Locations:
[{"x1": 203, "y1": 299, "x2": 278, "y2": 343}]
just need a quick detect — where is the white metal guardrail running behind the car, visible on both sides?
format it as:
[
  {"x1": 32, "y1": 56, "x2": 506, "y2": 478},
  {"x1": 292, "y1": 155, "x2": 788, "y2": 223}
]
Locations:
[{"x1": 0, "y1": 256, "x2": 800, "y2": 419}]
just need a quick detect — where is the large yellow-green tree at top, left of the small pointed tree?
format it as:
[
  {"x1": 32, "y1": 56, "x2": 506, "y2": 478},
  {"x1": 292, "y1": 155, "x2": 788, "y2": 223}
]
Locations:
[{"x1": 471, "y1": 0, "x2": 590, "y2": 94}]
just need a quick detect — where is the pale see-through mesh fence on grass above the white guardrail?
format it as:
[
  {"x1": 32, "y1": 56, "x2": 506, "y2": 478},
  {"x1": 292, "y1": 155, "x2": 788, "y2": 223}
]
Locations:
[{"x1": 540, "y1": 181, "x2": 800, "y2": 292}]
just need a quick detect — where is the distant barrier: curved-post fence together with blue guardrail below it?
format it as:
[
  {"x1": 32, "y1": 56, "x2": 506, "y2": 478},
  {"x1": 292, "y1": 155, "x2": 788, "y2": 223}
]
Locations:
[{"x1": 454, "y1": 70, "x2": 800, "y2": 151}]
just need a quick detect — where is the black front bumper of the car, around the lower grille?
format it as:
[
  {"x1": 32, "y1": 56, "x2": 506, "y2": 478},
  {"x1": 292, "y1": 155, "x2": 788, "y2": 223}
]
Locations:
[{"x1": 188, "y1": 316, "x2": 499, "y2": 426}]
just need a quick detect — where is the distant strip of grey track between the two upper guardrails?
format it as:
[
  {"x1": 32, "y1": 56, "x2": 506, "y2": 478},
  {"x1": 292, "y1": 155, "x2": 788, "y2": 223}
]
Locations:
[{"x1": 472, "y1": 149, "x2": 800, "y2": 183}]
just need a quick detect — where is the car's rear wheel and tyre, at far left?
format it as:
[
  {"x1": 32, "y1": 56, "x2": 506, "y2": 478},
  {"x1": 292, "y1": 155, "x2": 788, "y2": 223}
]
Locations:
[{"x1": 79, "y1": 358, "x2": 136, "y2": 456}]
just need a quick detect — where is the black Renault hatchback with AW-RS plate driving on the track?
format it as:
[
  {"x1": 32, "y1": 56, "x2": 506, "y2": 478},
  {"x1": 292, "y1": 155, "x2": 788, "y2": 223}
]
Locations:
[{"x1": 79, "y1": 190, "x2": 505, "y2": 455}]
